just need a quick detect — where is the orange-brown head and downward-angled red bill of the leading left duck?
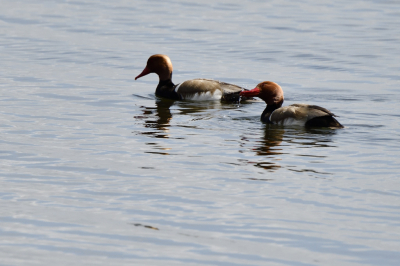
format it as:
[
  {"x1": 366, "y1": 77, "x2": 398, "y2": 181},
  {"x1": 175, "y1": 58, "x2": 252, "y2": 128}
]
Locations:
[{"x1": 135, "y1": 54, "x2": 173, "y2": 80}]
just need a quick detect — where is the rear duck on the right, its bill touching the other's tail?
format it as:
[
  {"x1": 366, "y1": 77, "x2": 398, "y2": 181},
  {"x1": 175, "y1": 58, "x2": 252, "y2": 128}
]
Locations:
[{"x1": 240, "y1": 81, "x2": 343, "y2": 128}]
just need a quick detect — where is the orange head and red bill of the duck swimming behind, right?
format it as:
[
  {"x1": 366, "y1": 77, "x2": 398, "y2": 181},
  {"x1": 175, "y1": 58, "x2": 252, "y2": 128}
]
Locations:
[{"x1": 240, "y1": 81, "x2": 283, "y2": 107}]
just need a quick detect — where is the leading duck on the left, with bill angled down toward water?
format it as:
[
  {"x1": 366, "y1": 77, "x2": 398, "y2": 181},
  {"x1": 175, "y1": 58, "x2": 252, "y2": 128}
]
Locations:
[{"x1": 135, "y1": 54, "x2": 247, "y2": 102}]
